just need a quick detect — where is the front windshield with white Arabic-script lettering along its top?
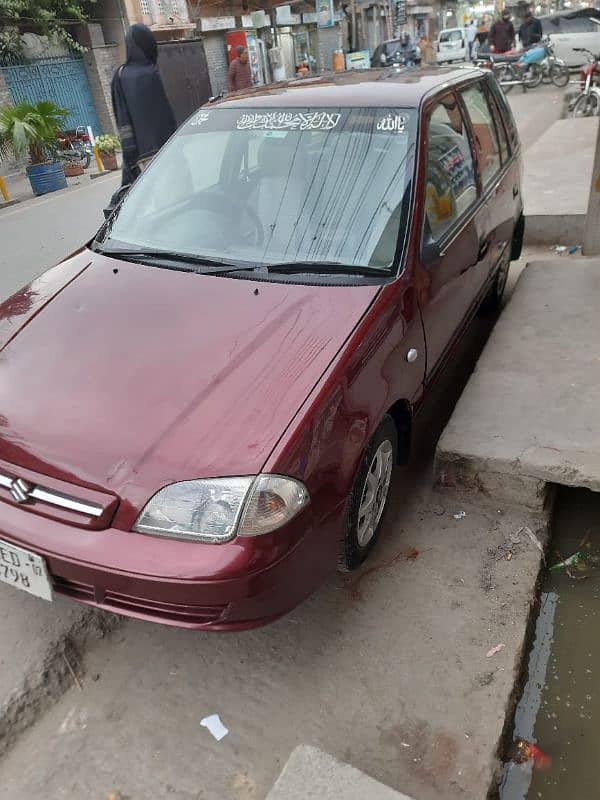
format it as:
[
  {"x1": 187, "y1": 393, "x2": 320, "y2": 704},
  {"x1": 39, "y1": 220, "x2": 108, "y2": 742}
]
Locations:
[{"x1": 100, "y1": 108, "x2": 416, "y2": 269}]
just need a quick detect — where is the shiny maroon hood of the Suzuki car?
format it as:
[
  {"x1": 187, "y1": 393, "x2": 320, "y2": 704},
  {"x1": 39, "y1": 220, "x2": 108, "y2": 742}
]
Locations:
[{"x1": 0, "y1": 250, "x2": 379, "y2": 504}]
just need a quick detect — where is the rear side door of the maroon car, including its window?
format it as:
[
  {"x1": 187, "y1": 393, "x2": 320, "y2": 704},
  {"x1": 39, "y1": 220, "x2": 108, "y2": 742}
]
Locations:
[{"x1": 460, "y1": 79, "x2": 519, "y2": 284}]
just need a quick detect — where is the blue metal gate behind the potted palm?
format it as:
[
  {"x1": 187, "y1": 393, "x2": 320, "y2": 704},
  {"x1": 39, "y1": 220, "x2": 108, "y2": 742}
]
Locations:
[{"x1": 1, "y1": 58, "x2": 101, "y2": 134}]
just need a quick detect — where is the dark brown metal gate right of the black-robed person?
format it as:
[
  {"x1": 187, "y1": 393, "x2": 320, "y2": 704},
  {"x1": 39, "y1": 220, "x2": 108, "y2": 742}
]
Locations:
[{"x1": 158, "y1": 39, "x2": 212, "y2": 125}]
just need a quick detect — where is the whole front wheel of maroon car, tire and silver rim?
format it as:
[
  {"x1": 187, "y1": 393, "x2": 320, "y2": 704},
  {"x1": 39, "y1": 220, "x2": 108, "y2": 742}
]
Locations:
[{"x1": 338, "y1": 414, "x2": 398, "y2": 572}]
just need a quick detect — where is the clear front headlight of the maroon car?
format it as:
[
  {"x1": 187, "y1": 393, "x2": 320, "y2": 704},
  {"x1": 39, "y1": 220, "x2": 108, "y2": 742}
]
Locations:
[{"x1": 133, "y1": 475, "x2": 310, "y2": 543}]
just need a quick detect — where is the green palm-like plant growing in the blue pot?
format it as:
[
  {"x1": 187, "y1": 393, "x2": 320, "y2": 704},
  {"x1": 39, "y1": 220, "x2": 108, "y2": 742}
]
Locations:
[{"x1": 0, "y1": 100, "x2": 68, "y2": 164}]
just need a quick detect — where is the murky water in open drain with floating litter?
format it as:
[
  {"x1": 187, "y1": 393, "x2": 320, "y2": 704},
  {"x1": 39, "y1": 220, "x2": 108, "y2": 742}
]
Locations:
[{"x1": 499, "y1": 489, "x2": 600, "y2": 800}]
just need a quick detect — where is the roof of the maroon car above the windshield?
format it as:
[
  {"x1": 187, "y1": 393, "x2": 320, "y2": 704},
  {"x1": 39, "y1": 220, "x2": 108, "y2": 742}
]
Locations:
[{"x1": 210, "y1": 66, "x2": 485, "y2": 108}]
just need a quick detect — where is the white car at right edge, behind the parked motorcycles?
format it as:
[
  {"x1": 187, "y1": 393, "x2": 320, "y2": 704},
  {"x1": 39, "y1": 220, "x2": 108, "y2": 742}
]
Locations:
[{"x1": 540, "y1": 8, "x2": 600, "y2": 67}]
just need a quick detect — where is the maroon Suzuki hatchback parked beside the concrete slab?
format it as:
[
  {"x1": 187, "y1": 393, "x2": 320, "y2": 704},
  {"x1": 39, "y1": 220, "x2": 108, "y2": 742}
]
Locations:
[{"x1": 0, "y1": 68, "x2": 523, "y2": 630}]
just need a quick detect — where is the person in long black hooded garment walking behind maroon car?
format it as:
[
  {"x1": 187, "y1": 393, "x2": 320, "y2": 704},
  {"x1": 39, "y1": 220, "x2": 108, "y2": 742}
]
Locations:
[{"x1": 111, "y1": 23, "x2": 177, "y2": 186}]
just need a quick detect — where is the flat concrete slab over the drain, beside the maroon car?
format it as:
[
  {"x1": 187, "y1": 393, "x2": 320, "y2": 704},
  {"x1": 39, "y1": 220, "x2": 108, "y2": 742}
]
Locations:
[{"x1": 436, "y1": 258, "x2": 600, "y2": 508}]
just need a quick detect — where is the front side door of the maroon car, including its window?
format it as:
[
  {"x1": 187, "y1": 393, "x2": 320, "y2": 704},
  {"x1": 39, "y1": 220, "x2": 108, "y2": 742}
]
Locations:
[{"x1": 417, "y1": 92, "x2": 489, "y2": 376}]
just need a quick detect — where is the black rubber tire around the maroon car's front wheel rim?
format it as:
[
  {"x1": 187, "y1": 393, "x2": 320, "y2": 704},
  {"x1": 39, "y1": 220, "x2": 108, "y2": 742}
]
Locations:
[{"x1": 338, "y1": 414, "x2": 398, "y2": 572}]
